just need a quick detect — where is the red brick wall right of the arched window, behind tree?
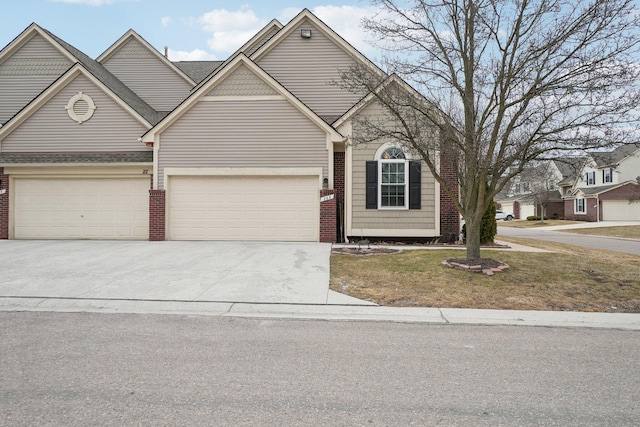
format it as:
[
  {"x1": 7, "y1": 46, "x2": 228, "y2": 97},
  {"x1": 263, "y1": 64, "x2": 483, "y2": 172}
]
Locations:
[{"x1": 440, "y1": 144, "x2": 460, "y2": 243}]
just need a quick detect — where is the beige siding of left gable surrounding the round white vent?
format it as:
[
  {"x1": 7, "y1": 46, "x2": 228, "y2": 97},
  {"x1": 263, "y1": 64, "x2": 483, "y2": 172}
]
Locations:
[{"x1": 2, "y1": 76, "x2": 146, "y2": 152}]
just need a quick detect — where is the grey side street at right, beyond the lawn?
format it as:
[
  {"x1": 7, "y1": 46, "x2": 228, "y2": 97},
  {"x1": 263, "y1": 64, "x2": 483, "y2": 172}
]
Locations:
[{"x1": 498, "y1": 226, "x2": 640, "y2": 256}]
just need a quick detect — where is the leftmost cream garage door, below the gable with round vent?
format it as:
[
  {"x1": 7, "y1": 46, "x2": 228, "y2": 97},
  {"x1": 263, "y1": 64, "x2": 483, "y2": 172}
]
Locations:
[{"x1": 13, "y1": 177, "x2": 149, "y2": 240}]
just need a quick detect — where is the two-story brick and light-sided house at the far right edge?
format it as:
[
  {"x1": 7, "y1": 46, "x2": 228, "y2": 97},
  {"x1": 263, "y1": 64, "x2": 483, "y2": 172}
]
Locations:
[{"x1": 564, "y1": 144, "x2": 640, "y2": 222}]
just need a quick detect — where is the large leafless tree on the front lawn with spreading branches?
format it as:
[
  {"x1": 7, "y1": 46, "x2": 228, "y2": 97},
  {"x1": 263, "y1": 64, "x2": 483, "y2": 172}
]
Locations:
[{"x1": 342, "y1": 0, "x2": 640, "y2": 259}]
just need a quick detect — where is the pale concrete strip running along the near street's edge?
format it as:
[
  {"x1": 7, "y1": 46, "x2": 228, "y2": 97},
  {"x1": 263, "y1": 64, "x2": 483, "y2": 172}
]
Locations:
[{"x1": 0, "y1": 297, "x2": 640, "y2": 331}]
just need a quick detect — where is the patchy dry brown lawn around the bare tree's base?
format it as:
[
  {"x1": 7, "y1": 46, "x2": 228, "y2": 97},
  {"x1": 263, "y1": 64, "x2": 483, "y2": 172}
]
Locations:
[{"x1": 331, "y1": 239, "x2": 640, "y2": 313}]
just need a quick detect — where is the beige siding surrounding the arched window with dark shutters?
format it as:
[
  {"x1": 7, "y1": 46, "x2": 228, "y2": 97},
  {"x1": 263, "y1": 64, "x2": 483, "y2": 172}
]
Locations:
[{"x1": 351, "y1": 104, "x2": 439, "y2": 235}]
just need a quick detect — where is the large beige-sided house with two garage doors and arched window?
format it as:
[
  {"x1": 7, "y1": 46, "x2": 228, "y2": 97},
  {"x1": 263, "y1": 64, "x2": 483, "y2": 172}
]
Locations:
[{"x1": 0, "y1": 9, "x2": 459, "y2": 242}]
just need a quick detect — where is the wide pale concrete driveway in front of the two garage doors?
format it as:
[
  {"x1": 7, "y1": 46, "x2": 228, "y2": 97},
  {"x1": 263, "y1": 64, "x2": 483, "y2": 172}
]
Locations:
[{"x1": 0, "y1": 240, "x2": 358, "y2": 304}]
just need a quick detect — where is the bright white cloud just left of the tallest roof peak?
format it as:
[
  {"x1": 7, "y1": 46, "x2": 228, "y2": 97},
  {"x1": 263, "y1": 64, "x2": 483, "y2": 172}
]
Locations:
[{"x1": 197, "y1": 6, "x2": 269, "y2": 53}]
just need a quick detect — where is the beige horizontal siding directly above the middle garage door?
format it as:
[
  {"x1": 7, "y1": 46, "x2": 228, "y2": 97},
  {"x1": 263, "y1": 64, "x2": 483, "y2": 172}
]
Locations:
[{"x1": 158, "y1": 100, "x2": 329, "y2": 188}]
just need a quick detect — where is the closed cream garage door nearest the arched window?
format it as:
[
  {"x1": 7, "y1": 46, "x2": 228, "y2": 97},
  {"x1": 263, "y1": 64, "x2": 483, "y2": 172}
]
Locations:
[{"x1": 167, "y1": 176, "x2": 320, "y2": 241}]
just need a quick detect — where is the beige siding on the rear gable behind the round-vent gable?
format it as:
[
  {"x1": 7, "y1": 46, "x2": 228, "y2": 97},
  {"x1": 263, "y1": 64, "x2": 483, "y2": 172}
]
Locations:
[{"x1": 102, "y1": 39, "x2": 192, "y2": 111}]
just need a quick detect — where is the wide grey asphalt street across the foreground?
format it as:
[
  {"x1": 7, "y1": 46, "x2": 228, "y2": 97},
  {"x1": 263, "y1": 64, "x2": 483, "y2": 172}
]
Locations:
[{"x1": 0, "y1": 312, "x2": 640, "y2": 426}]
